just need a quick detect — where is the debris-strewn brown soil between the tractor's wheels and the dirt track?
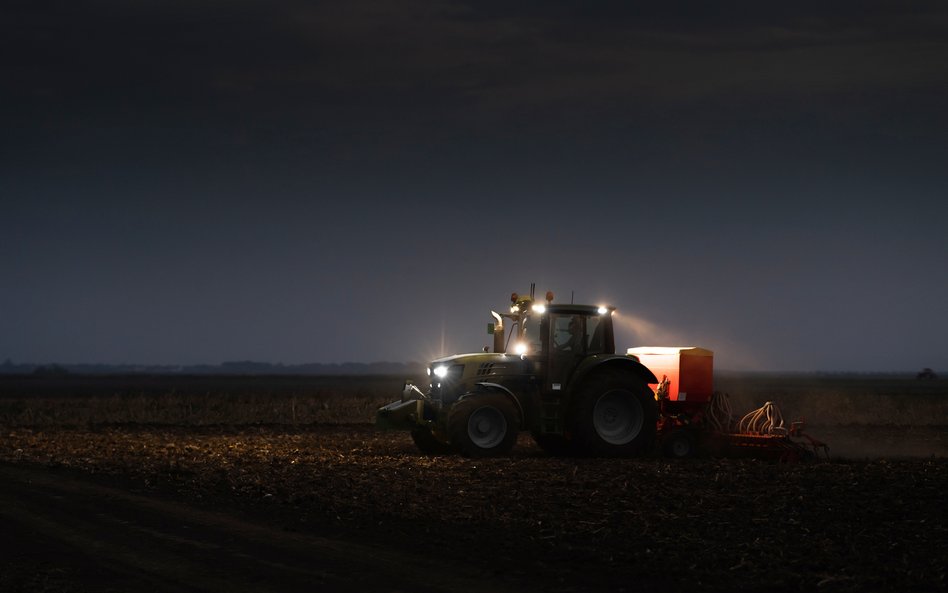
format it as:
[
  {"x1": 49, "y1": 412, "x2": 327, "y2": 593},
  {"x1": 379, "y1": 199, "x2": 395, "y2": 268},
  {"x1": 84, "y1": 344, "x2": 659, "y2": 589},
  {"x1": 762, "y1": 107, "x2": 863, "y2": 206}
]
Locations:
[{"x1": 2, "y1": 424, "x2": 948, "y2": 590}]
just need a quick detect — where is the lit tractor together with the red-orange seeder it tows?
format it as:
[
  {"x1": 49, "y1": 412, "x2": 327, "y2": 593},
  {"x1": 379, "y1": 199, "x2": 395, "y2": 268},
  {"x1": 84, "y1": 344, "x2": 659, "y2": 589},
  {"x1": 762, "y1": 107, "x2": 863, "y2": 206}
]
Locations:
[{"x1": 376, "y1": 288, "x2": 827, "y2": 462}]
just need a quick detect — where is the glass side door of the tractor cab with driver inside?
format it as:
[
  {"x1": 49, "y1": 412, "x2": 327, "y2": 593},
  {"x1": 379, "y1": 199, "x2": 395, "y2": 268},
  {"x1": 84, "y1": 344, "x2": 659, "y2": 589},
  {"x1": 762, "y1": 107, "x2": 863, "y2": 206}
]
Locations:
[{"x1": 544, "y1": 313, "x2": 605, "y2": 394}]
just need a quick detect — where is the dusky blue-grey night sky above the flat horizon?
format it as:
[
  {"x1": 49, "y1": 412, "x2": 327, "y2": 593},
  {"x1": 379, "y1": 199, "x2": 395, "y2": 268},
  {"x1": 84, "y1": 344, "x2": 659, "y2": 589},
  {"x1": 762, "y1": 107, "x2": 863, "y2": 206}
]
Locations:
[{"x1": 0, "y1": 0, "x2": 948, "y2": 371}]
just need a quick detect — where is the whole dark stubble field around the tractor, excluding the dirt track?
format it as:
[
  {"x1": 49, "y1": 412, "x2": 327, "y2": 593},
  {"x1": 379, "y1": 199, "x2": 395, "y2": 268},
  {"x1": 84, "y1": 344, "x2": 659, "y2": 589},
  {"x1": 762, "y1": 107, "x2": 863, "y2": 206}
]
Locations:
[{"x1": 0, "y1": 377, "x2": 948, "y2": 591}]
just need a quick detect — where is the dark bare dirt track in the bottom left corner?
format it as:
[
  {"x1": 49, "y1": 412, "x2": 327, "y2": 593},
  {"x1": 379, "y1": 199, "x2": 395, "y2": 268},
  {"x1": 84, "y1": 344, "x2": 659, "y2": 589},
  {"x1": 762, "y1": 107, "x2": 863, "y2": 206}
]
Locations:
[{"x1": 0, "y1": 465, "x2": 504, "y2": 591}]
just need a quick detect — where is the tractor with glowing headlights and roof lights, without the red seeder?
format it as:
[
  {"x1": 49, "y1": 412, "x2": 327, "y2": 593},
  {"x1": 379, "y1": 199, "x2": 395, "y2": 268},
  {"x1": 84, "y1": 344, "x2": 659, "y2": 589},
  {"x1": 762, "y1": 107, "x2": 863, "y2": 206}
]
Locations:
[{"x1": 376, "y1": 290, "x2": 658, "y2": 457}]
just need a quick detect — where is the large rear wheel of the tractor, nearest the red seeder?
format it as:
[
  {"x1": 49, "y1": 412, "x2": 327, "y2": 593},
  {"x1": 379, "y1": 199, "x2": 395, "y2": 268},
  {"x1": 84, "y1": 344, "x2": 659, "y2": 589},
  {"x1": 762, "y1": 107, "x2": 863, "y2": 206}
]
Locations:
[{"x1": 572, "y1": 373, "x2": 658, "y2": 457}]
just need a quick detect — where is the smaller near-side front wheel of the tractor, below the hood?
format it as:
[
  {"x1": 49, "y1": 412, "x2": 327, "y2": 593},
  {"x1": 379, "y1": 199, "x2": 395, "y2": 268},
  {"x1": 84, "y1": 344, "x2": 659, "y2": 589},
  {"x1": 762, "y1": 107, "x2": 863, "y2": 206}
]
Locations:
[{"x1": 448, "y1": 393, "x2": 520, "y2": 457}]
